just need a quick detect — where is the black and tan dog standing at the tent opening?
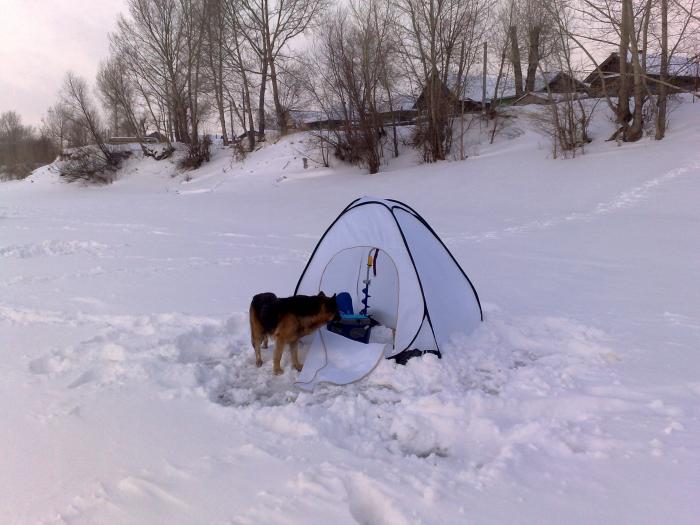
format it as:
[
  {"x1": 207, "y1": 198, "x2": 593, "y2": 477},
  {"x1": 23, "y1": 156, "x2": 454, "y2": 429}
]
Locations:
[{"x1": 250, "y1": 292, "x2": 339, "y2": 375}]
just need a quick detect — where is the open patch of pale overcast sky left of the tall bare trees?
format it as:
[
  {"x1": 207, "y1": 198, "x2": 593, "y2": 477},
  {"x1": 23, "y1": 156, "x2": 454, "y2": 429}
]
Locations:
[{"x1": 0, "y1": 0, "x2": 125, "y2": 125}]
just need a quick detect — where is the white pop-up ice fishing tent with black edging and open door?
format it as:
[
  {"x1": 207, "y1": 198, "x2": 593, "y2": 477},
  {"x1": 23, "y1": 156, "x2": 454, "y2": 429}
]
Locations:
[{"x1": 295, "y1": 197, "x2": 483, "y2": 387}]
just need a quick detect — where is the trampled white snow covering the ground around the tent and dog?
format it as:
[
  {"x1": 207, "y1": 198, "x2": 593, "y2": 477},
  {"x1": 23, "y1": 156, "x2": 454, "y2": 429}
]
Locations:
[{"x1": 0, "y1": 101, "x2": 700, "y2": 525}]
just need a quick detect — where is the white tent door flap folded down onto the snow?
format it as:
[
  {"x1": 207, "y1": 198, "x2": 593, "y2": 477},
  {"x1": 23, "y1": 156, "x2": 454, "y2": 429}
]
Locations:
[{"x1": 295, "y1": 328, "x2": 386, "y2": 391}]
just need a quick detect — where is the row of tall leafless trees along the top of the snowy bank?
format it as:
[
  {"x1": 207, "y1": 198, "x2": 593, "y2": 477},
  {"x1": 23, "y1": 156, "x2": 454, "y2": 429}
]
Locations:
[{"x1": 2, "y1": 0, "x2": 700, "y2": 180}]
